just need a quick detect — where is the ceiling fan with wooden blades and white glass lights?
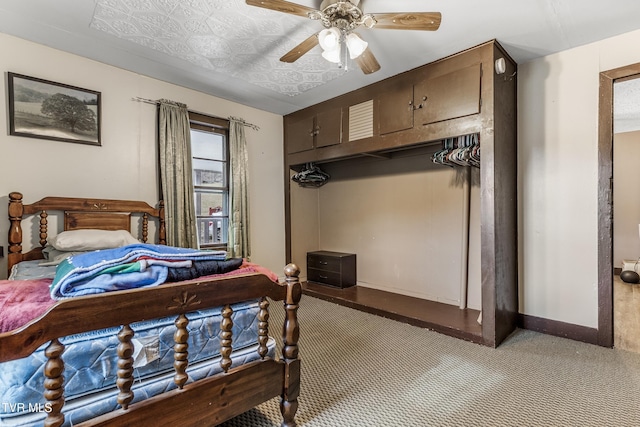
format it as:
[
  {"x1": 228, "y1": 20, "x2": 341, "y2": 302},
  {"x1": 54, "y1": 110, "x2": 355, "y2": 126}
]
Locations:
[{"x1": 246, "y1": 0, "x2": 442, "y2": 74}]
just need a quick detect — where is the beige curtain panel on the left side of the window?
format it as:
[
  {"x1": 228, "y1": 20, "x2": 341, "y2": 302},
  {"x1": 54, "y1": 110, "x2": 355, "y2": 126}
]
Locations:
[{"x1": 158, "y1": 99, "x2": 198, "y2": 248}]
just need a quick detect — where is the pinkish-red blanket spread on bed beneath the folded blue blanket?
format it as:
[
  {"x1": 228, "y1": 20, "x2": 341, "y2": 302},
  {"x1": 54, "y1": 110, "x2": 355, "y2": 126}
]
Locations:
[{"x1": 0, "y1": 261, "x2": 278, "y2": 333}]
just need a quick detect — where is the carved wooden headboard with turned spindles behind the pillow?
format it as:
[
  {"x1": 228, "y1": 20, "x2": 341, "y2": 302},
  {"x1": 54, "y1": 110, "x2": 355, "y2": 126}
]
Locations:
[{"x1": 7, "y1": 192, "x2": 166, "y2": 271}]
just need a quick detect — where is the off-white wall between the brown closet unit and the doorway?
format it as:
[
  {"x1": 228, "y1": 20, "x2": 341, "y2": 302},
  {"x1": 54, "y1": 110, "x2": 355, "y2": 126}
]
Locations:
[{"x1": 518, "y1": 31, "x2": 640, "y2": 328}]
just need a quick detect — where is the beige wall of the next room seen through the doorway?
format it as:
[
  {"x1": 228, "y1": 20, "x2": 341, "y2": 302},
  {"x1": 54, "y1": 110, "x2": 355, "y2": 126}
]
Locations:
[{"x1": 613, "y1": 132, "x2": 640, "y2": 268}]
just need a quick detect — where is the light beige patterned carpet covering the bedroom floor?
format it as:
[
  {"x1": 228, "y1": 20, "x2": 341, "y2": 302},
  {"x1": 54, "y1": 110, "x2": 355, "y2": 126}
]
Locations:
[{"x1": 224, "y1": 295, "x2": 640, "y2": 427}]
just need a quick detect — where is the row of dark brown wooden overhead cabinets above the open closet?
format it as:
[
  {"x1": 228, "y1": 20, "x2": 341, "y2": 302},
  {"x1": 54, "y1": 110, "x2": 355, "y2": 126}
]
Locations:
[{"x1": 284, "y1": 55, "x2": 484, "y2": 165}]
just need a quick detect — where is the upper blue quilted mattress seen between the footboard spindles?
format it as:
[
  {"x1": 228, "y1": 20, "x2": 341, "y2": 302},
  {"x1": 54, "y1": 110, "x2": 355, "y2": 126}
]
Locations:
[{"x1": 0, "y1": 301, "x2": 260, "y2": 425}]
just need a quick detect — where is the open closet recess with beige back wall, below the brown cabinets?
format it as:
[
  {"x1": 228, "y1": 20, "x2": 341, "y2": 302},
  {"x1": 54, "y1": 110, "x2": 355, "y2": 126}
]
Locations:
[{"x1": 291, "y1": 134, "x2": 482, "y2": 342}]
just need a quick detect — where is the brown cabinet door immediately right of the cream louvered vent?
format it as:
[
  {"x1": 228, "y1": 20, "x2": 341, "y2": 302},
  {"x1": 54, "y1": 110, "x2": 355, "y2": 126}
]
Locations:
[{"x1": 377, "y1": 85, "x2": 413, "y2": 135}]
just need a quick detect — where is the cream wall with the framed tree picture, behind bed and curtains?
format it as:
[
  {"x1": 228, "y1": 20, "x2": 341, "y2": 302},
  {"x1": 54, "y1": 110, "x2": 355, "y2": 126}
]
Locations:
[{"x1": 0, "y1": 34, "x2": 285, "y2": 277}]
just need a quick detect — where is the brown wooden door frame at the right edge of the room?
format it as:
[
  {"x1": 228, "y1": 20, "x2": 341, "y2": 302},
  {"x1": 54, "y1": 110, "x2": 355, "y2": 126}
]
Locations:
[{"x1": 598, "y1": 63, "x2": 640, "y2": 347}]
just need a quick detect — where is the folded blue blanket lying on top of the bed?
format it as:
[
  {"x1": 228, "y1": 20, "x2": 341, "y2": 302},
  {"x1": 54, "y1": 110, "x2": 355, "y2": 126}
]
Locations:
[{"x1": 50, "y1": 243, "x2": 227, "y2": 300}]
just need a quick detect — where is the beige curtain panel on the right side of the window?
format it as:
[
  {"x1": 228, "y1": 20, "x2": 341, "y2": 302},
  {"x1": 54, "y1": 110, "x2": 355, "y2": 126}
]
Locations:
[{"x1": 227, "y1": 117, "x2": 251, "y2": 259}]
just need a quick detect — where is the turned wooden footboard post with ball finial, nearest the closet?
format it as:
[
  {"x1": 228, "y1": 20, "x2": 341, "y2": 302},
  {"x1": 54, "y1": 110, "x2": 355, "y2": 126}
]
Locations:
[{"x1": 280, "y1": 264, "x2": 302, "y2": 427}]
